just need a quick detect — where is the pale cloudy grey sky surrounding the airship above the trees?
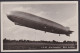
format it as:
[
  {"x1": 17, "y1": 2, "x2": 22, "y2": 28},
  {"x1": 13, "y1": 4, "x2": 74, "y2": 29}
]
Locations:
[{"x1": 1, "y1": 2, "x2": 78, "y2": 41}]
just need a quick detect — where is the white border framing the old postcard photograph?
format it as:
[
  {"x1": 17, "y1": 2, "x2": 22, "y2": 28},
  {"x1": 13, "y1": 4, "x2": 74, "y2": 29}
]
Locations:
[{"x1": 1, "y1": 1, "x2": 79, "y2": 52}]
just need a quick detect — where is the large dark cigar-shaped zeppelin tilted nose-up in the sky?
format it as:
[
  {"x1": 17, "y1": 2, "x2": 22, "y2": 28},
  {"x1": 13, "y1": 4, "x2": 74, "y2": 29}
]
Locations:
[{"x1": 7, "y1": 11, "x2": 73, "y2": 36}]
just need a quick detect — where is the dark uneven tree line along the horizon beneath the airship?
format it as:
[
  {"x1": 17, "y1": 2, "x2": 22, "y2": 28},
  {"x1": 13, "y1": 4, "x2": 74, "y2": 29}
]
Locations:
[{"x1": 3, "y1": 38, "x2": 77, "y2": 44}]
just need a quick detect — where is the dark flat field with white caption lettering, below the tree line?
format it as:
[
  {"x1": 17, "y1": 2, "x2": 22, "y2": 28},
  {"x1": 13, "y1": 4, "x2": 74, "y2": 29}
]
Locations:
[{"x1": 3, "y1": 42, "x2": 77, "y2": 50}]
